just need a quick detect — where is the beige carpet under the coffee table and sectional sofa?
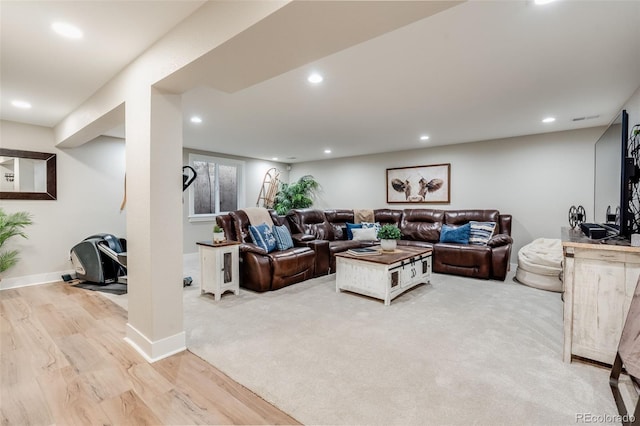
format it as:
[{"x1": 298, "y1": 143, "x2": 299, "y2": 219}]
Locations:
[{"x1": 105, "y1": 268, "x2": 636, "y2": 425}]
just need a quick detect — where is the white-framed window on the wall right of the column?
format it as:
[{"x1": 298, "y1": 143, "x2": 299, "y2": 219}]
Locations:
[{"x1": 189, "y1": 154, "x2": 244, "y2": 220}]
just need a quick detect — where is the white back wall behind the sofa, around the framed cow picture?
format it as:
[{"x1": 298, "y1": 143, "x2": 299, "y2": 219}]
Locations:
[{"x1": 291, "y1": 127, "x2": 604, "y2": 261}]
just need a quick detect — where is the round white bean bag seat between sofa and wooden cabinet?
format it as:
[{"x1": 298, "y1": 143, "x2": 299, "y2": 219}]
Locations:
[{"x1": 516, "y1": 238, "x2": 562, "y2": 292}]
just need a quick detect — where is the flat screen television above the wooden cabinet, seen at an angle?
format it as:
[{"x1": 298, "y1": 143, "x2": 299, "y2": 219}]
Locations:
[{"x1": 593, "y1": 110, "x2": 640, "y2": 239}]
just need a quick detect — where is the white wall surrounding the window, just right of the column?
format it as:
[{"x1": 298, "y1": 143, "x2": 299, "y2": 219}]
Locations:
[{"x1": 182, "y1": 149, "x2": 289, "y2": 253}]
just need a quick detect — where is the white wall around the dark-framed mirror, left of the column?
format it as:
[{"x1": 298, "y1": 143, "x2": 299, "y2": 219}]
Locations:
[{"x1": 0, "y1": 121, "x2": 125, "y2": 288}]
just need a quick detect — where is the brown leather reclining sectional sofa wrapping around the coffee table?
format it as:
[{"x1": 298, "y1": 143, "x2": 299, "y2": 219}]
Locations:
[{"x1": 217, "y1": 209, "x2": 513, "y2": 291}]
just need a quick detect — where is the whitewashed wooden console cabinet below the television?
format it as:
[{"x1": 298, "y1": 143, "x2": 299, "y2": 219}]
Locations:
[{"x1": 562, "y1": 229, "x2": 640, "y2": 365}]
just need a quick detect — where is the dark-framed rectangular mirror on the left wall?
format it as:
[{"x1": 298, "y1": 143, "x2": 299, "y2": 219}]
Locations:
[{"x1": 0, "y1": 148, "x2": 57, "y2": 200}]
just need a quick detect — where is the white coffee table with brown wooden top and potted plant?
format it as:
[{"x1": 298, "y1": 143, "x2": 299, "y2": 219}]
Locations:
[{"x1": 336, "y1": 246, "x2": 433, "y2": 306}]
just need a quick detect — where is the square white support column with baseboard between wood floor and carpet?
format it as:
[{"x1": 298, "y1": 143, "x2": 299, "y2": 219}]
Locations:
[{"x1": 125, "y1": 86, "x2": 186, "y2": 362}]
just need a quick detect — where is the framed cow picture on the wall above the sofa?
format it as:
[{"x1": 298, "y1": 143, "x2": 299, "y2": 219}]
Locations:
[{"x1": 387, "y1": 164, "x2": 451, "y2": 204}]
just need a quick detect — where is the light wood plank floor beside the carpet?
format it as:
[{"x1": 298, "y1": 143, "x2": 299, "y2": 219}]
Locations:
[{"x1": 0, "y1": 282, "x2": 299, "y2": 425}]
